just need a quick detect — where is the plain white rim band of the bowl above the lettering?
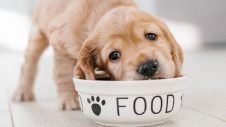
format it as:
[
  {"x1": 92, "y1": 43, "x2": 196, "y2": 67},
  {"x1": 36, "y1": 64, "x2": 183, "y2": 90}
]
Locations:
[{"x1": 73, "y1": 76, "x2": 187, "y2": 95}]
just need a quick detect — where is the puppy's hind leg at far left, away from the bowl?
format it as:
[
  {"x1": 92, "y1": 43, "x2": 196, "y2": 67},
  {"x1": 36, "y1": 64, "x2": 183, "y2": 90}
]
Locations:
[{"x1": 13, "y1": 27, "x2": 48, "y2": 102}]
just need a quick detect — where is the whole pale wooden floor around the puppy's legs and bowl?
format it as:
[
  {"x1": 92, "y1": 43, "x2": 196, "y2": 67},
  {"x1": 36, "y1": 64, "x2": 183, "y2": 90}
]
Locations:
[{"x1": 0, "y1": 50, "x2": 226, "y2": 127}]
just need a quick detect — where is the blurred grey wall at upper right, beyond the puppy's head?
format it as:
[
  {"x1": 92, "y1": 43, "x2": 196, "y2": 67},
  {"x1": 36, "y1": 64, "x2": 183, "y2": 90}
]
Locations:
[{"x1": 156, "y1": 0, "x2": 226, "y2": 43}]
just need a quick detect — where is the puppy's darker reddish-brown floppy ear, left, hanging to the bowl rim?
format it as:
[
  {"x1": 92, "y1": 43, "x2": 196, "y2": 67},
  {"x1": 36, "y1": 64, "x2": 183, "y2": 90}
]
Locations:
[{"x1": 74, "y1": 39, "x2": 98, "y2": 80}]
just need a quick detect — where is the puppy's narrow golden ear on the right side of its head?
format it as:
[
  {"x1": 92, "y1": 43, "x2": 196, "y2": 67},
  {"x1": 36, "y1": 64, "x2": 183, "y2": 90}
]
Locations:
[{"x1": 163, "y1": 25, "x2": 184, "y2": 77}]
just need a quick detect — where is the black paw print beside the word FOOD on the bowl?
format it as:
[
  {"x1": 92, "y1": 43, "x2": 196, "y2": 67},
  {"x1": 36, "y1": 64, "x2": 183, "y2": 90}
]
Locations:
[{"x1": 87, "y1": 96, "x2": 106, "y2": 116}]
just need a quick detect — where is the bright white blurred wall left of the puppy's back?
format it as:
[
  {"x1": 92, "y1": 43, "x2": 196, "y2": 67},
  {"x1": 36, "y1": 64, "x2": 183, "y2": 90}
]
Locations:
[{"x1": 0, "y1": 0, "x2": 35, "y2": 51}]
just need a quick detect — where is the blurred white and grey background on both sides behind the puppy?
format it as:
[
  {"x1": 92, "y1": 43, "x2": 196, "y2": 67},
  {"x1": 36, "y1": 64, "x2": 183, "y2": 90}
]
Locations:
[{"x1": 0, "y1": 0, "x2": 226, "y2": 51}]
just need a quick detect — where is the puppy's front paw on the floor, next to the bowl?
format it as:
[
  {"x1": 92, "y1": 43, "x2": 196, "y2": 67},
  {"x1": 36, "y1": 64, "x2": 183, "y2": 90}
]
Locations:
[{"x1": 59, "y1": 97, "x2": 80, "y2": 110}]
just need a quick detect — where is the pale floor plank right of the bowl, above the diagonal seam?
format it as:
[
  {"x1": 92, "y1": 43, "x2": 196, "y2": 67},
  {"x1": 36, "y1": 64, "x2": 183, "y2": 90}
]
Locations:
[{"x1": 184, "y1": 50, "x2": 226, "y2": 121}]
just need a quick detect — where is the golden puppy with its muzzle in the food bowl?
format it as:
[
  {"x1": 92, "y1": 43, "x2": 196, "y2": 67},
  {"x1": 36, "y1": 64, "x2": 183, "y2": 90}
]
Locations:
[{"x1": 14, "y1": 0, "x2": 183, "y2": 109}]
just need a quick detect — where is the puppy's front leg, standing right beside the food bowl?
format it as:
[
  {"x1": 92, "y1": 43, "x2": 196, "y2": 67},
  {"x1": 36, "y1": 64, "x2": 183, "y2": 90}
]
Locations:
[{"x1": 54, "y1": 50, "x2": 80, "y2": 110}]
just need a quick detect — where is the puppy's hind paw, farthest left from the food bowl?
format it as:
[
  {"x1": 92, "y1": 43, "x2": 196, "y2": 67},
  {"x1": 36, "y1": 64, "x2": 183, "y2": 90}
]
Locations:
[{"x1": 12, "y1": 88, "x2": 34, "y2": 102}]
